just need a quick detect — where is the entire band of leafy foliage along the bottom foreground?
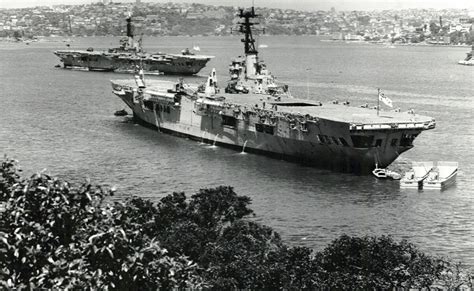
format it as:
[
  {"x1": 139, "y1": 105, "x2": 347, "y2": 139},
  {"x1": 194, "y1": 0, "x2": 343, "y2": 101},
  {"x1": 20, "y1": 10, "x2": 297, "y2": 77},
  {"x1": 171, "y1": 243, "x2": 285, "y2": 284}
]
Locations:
[{"x1": 0, "y1": 159, "x2": 472, "y2": 290}]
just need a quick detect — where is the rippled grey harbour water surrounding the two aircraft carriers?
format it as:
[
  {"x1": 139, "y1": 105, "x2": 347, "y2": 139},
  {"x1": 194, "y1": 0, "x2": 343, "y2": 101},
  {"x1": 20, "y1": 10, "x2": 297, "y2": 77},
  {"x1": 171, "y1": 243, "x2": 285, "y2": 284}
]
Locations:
[{"x1": 0, "y1": 37, "x2": 474, "y2": 267}]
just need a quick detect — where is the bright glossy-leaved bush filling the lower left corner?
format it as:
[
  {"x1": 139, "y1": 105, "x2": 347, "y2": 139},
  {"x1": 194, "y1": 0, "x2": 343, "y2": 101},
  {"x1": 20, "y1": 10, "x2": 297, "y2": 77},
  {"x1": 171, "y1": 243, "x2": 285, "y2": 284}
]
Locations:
[{"x1": 0, "y1": 160, "x2": 202, "y2": 289}]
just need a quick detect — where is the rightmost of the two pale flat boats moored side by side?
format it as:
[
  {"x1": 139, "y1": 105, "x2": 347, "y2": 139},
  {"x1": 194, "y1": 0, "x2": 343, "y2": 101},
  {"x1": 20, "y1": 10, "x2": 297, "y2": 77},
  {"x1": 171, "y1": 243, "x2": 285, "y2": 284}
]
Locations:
[{"x1": 423, "y1": 162, "x2": 458, "y2": 189}]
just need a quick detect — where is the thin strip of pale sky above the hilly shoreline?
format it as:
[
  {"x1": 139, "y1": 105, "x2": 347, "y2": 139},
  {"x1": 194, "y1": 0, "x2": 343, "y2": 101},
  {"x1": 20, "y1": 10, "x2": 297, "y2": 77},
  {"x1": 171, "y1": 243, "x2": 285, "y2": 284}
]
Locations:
[{"x1": 0, "y1": 0, "x2": 474, "y2": 10}]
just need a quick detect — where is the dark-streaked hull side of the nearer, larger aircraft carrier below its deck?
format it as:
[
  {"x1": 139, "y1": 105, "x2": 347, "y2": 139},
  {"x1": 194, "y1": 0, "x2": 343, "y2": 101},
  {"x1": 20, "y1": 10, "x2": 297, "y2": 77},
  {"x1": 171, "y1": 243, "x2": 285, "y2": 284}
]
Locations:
[{"x1": 111, "y1": 85, "x2": 421, "y2": 174}]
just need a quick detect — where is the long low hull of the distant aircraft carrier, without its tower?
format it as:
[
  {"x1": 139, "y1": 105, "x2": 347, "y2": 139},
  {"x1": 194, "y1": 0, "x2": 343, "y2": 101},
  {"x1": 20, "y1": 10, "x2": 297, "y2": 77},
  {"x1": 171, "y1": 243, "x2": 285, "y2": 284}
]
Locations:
[{"x1": 55, "y1": 51, "x2": 210, "y2": 75}]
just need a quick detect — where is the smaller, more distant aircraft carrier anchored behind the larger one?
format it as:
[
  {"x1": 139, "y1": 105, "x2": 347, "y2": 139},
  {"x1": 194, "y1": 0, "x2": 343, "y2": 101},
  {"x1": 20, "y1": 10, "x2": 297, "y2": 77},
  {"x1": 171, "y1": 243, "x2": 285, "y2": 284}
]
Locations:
[{"x1": 54, "y1": 16, "x2": 213, "y2": 75}]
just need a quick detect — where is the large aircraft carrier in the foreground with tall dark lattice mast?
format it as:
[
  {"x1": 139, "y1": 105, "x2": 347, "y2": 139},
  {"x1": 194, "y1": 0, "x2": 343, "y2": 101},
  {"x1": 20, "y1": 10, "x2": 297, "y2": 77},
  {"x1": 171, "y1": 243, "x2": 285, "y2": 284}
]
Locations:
[{"x1": 111, "y1": 7, "x2": 435, "y2": 174}]
